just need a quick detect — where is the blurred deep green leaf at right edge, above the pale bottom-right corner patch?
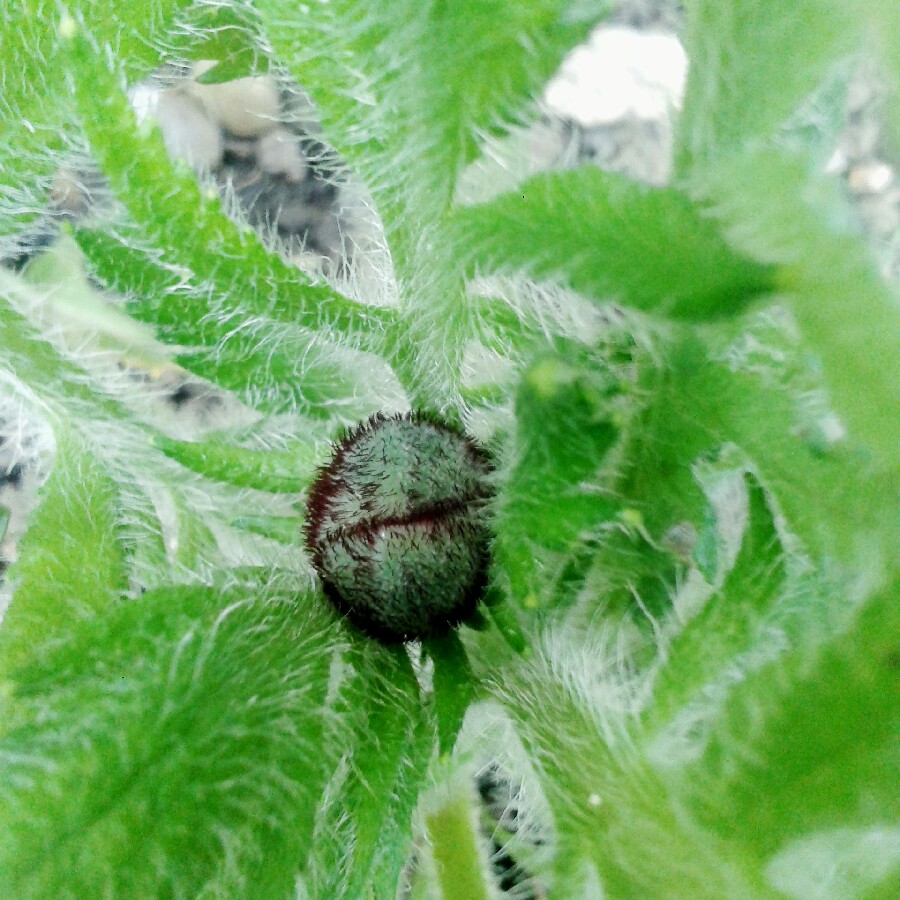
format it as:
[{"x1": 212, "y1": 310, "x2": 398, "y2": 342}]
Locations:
[{"x1": 684, "y1": 584, "x2": 900, "y2": 858}]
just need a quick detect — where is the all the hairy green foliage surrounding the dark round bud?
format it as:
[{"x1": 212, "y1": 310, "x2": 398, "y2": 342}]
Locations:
[{"x1": 0, "y1": 0, "x2": 900, "y2": 900}]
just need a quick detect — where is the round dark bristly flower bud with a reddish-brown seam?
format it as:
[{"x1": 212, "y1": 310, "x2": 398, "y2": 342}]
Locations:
[{"x1": 306, "y1": 412, "x2": 491, "y2": 643}]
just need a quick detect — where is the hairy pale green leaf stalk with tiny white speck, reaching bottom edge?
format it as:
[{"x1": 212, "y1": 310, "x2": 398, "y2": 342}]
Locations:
[{"x1": 490, "y1": 627, "x2": 775, "y2": 900}]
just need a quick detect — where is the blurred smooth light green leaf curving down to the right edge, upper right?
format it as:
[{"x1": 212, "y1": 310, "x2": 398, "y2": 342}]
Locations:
[{"x1": 694, "y1": 151, "x2": 900, "y2": 466}]
